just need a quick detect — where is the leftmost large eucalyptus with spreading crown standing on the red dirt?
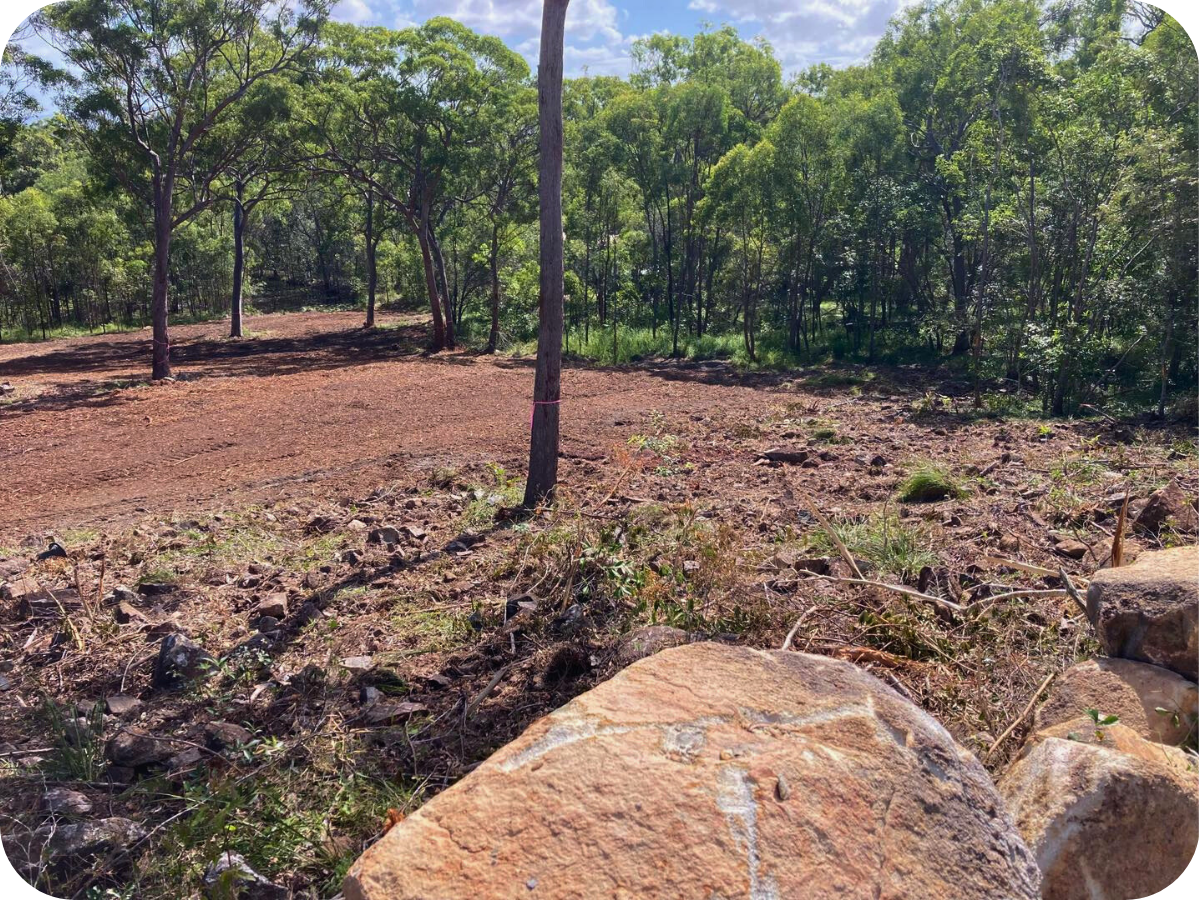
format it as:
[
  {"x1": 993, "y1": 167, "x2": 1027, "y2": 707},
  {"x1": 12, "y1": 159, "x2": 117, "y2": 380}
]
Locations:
[{"x1": 43, "y1": 0, "x2": 329, "y2": 379}]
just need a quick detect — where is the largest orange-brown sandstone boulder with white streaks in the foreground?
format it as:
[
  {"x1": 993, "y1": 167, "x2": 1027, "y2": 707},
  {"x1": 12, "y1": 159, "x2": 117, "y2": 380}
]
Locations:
[{"x1": 346, "y1": 643, "x2": 1038, "y2": 900}]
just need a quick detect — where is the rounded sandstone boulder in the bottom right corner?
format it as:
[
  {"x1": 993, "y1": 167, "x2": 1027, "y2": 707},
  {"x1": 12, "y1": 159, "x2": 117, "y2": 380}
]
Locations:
[{"x1": 1000, "y1": 725, "x2": 1200, "y2": 900}]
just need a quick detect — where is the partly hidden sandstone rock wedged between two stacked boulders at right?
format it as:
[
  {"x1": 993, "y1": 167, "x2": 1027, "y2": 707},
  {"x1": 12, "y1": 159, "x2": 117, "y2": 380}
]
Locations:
[{"x1": 1033, "y1": 659, "x2": 1200, "y2": 745}]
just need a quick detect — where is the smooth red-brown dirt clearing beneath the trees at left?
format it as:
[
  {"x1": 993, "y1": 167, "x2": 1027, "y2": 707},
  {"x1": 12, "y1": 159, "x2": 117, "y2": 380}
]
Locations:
[{"x1": 0, "y1": 312, "x2": 755, "y2": 544}]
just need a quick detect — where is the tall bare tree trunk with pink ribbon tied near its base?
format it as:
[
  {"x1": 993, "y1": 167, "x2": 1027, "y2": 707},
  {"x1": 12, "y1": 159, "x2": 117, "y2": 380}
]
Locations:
[{"x1": 524, "y1": 0, "x2": 569, "y2": 509}]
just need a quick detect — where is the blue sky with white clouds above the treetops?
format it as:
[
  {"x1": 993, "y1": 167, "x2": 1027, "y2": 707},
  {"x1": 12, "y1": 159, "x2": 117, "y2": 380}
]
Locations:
[{"x1": 334, "y1": 0, "x2": 913, "y2": 76}]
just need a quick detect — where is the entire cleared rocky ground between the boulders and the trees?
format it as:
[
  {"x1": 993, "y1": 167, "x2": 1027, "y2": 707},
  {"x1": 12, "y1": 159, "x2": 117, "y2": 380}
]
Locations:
[{"x1": 0, "y1": 316, "x2": 1198, "y2": 898}]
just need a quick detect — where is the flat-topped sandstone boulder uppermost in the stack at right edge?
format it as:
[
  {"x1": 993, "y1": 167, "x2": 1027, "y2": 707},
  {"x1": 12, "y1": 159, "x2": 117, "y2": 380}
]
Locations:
[{"x1": 1087, "y1": 546, "x2": 1200, "y2": 682}]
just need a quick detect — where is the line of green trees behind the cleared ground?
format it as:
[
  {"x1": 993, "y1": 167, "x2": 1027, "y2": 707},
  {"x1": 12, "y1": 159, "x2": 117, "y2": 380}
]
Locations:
[{"x1": 0, "y1": 0, "x2": 1200, "y2": 414}]
